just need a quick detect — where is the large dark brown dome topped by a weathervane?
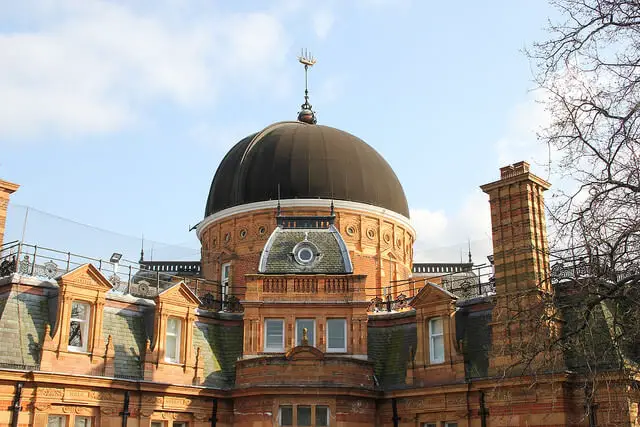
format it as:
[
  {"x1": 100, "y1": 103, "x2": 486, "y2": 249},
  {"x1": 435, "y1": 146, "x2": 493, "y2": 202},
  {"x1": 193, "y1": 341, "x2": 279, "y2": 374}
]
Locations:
[{"x1": 205, "y1": 122, "x2": 409, "y2": 218}]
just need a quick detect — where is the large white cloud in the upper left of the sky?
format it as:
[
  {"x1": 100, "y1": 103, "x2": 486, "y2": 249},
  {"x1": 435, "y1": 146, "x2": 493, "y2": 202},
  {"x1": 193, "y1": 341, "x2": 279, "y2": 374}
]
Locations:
[{"x1": 0, "y1": 0, "x2": 289, "y2": 139}]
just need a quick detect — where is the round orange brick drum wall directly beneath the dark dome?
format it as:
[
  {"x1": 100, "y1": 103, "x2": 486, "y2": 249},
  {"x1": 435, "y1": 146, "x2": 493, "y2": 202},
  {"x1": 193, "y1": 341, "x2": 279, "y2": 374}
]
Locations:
[{"x1": 200, "y1": 207, "x2": 415, "y2": 298}]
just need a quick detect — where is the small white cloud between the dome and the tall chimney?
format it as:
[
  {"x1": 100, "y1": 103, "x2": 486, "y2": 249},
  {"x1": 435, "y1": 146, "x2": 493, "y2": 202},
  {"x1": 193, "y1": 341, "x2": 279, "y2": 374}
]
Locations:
[{"x1": 411, "y1": 190, "x2": 492, "y2": 262}]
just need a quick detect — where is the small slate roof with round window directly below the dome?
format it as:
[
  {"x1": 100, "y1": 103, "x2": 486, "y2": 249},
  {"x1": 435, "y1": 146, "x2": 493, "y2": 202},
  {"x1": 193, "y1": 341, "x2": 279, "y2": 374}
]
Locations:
[{"x1": 258, "y1": 226, "x2": 353, "y2": 274}]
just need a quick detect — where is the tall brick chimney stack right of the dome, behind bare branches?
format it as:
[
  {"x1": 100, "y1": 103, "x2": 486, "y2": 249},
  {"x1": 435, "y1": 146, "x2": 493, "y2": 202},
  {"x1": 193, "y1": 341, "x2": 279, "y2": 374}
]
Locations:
[{"x1": 480, "y1": 162, "x2": 552, "y2": 370}]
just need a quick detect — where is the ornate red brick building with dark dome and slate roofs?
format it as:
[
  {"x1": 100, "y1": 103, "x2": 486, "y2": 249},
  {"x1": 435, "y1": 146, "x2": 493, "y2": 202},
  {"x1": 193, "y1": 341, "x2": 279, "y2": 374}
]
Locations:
[{"x1": 0, "y1": 106, "x2": 638, "y2": 427}]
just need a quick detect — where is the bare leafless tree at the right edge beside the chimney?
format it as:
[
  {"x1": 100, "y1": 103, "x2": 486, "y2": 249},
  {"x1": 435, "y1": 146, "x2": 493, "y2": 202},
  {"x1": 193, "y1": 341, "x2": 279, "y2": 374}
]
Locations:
[{"x1": 527, "y1": 0, "x2": 640, "y2": 422}]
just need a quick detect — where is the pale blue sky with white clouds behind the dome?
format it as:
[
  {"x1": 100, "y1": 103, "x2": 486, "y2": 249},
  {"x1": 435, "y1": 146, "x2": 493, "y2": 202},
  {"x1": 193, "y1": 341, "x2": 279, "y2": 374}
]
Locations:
[{"x1": 0, "y1": 0, "x2": 553, "y2": 262}]
